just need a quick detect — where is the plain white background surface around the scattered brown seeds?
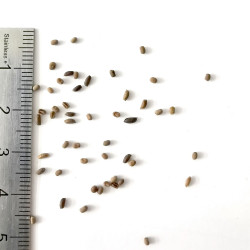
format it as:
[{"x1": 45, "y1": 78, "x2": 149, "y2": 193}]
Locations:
[{"x1": 0, "y1": 0, "x2": 250, "y2": 250}]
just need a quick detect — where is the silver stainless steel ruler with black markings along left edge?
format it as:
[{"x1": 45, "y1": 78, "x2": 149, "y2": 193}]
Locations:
[{"x1": 0, "y1": 29, "x2": 35, "y2": 250}]
